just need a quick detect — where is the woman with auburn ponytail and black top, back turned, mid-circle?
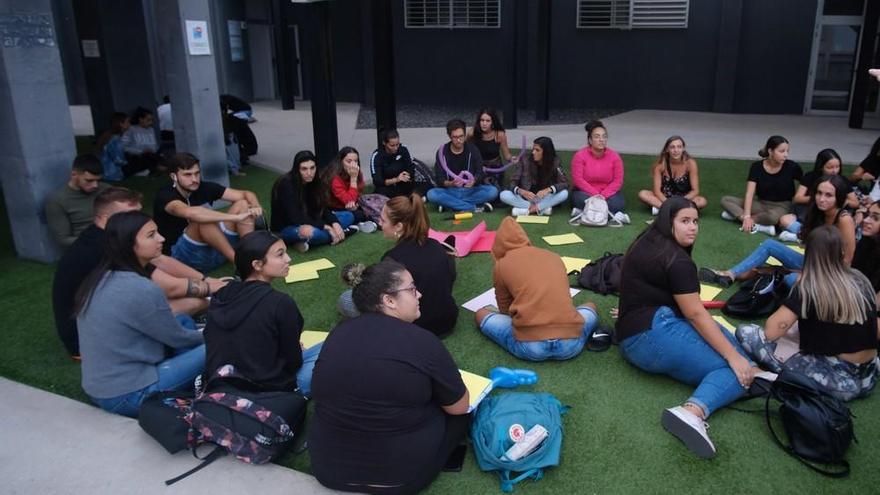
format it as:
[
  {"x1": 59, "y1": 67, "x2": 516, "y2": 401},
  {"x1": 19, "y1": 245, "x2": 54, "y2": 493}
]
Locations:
[{"x1": 339, "y1": 193, "x2": 458, "y2": 336}]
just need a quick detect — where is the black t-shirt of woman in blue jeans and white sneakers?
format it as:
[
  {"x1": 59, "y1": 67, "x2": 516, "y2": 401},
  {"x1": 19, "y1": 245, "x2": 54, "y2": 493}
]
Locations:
[{"x1": 617, "y1": 233, "x2": 700, "y2": 340}]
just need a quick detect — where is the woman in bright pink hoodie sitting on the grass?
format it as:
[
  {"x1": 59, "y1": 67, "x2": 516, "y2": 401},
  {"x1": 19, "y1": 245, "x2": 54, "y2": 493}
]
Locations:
[{"x1": 571, "y1": 120, "x2": 630, "y2": 223}]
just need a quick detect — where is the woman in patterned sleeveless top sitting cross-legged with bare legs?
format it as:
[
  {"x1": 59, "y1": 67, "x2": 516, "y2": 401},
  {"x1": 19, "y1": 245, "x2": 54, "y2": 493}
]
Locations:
[{"x1": 639, "y1": 136, "x2": 708, "y2": 215}]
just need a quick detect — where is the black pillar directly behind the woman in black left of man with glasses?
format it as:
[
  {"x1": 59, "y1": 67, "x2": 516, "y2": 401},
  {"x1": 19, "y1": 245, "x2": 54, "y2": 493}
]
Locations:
[{"x1": 370, "y1": 0, "x2": 397, "y2": 148}]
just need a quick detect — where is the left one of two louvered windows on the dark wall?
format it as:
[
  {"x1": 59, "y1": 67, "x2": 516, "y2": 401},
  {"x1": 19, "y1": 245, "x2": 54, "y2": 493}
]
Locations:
[{"x1": 403, "y1": 0, "x2": 501, "y2": 29}]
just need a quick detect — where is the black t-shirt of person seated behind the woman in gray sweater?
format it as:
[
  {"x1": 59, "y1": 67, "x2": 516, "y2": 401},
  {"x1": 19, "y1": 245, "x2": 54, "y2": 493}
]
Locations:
[{"x1": 52, "y1": 224, "x2": 104, "y2": 356}]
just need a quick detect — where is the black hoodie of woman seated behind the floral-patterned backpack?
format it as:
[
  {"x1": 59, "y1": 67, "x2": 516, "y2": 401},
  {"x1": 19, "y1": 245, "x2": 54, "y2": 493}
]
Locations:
[{"x1": 205, "y1": 282, "x2": 303, "y2": 390}]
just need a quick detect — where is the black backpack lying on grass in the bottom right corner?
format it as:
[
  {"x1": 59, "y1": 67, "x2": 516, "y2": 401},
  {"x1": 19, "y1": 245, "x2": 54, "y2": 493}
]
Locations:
[{"x1": 764, "y1": 370, "x2": 855, "y2": 478}]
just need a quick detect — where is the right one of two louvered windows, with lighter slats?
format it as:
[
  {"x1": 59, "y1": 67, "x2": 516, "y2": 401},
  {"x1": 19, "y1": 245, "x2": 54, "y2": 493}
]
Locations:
[{"x1": 577, "y1": 0, "x2": 690, "y2": 29}]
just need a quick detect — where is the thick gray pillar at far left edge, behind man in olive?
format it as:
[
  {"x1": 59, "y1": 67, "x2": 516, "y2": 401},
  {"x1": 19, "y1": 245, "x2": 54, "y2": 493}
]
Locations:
[{"x1": 0, "y1": 0, "x2": 76, "y2": 262}]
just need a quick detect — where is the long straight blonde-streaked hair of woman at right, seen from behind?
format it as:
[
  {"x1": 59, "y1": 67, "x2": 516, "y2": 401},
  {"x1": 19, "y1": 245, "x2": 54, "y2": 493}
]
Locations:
[{"x1": 795, "y1": 225, "x2": 874, "y2": 325}]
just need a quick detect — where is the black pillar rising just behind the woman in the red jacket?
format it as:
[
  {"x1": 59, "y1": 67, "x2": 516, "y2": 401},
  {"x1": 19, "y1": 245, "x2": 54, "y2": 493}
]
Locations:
[{"x1": 304, "y1": 2, "x2": 339, "y2": 167}]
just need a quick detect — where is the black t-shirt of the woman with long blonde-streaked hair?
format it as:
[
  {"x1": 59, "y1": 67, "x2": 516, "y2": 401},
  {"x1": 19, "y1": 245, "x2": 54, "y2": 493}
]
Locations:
[{"x1": 782, "y1": 287, "x2": 877, "y2": 356}]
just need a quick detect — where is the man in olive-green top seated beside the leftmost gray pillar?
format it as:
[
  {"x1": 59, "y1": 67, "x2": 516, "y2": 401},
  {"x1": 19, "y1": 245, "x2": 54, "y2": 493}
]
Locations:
[{"x1": 45, "y1": 154, "x2": 110, "y2": 249}]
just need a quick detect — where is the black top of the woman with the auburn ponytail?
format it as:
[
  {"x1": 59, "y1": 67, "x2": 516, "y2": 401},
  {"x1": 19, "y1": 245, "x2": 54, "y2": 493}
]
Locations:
[{"x1": 382, "y1": 239, "x2": 458, "y2": 335}]
